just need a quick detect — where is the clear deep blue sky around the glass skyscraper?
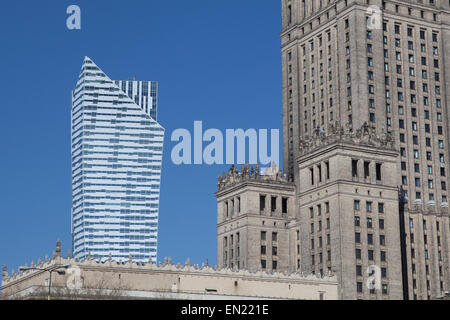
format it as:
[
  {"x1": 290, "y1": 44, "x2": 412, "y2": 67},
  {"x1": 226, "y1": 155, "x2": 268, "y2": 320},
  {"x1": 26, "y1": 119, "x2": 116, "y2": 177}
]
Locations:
[{"x1": 0, "y1": 0, "x2": 281, "y2": 271}]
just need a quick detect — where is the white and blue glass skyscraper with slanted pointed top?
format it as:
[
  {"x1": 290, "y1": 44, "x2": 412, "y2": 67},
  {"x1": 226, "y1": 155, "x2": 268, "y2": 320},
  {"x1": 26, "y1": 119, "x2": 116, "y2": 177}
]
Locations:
[{"x1": 71, "y1": 57, "x2": 164, "y2": 262}]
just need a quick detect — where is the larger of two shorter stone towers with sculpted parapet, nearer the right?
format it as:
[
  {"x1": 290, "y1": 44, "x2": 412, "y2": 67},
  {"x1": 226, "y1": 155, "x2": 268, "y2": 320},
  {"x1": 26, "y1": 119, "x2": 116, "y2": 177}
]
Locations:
[{"x1": 297, "y1": 124, "x2": 403, "y2": 299}]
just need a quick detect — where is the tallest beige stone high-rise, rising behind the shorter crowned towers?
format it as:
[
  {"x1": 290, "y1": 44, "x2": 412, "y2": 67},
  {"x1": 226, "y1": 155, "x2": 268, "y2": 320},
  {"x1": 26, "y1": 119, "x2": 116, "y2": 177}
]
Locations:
[{"x1": 281, "y1": 0, "x2": 450, "y2": 299}]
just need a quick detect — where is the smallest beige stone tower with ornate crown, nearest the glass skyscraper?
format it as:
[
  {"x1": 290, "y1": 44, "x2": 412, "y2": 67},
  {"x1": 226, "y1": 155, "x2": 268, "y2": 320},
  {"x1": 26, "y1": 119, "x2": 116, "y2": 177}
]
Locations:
[{"x1": 216, "y1": 165, "x2": 296, "y2": 271}]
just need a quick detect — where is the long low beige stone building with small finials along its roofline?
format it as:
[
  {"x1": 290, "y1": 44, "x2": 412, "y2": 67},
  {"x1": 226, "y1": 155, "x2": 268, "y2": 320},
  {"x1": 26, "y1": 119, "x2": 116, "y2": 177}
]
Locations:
[{"x1": 1, "y1": 242, "x2": 338, "y2": 300}]
